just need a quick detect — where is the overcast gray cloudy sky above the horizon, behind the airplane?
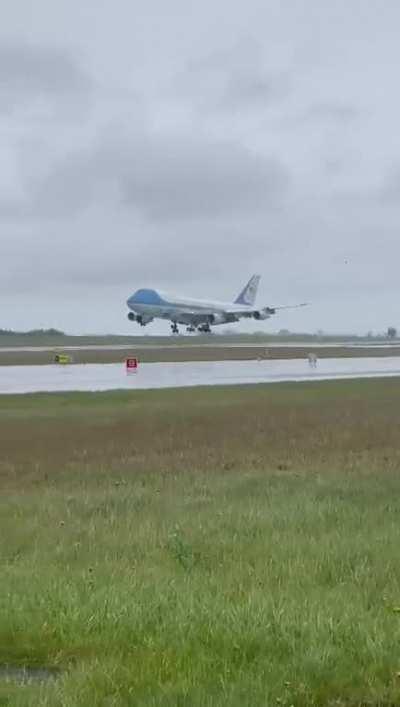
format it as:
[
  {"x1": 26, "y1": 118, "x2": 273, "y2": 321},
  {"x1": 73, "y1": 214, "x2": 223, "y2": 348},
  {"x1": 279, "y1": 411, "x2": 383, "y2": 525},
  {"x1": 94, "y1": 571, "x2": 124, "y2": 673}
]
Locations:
[{"x1": 0, "y1": 0, "x2": 400, "y2": 333}]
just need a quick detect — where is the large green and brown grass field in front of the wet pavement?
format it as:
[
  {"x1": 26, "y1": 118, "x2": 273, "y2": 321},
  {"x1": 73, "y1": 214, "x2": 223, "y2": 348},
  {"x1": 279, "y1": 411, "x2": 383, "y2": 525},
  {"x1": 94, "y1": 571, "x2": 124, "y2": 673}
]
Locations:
[{"x1": 0, "y1": 379, "x2": 400, "y2": 707}]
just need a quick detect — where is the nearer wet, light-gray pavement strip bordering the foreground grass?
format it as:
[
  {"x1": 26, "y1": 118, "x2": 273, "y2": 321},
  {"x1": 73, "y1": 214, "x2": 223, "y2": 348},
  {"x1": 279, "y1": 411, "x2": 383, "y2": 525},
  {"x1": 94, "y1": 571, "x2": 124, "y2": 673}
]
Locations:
[{"x1": 0, "y1": 357, "x2": 400, "y2": 394}]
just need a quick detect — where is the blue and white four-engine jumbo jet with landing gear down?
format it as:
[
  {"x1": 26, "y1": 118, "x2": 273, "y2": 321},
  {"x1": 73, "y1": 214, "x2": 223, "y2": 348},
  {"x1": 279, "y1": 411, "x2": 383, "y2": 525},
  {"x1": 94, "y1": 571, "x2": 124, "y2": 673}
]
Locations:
[{"x1": 127, "y1": 275, "x2": 307, "y2": 334}]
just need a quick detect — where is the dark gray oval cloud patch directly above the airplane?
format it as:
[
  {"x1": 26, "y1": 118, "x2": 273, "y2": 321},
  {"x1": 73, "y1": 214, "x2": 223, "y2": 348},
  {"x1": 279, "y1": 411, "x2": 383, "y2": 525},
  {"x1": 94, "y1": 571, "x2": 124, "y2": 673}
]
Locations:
[{"x1": 118, "y1": 133, "x2": 288, "y2": 219}]
